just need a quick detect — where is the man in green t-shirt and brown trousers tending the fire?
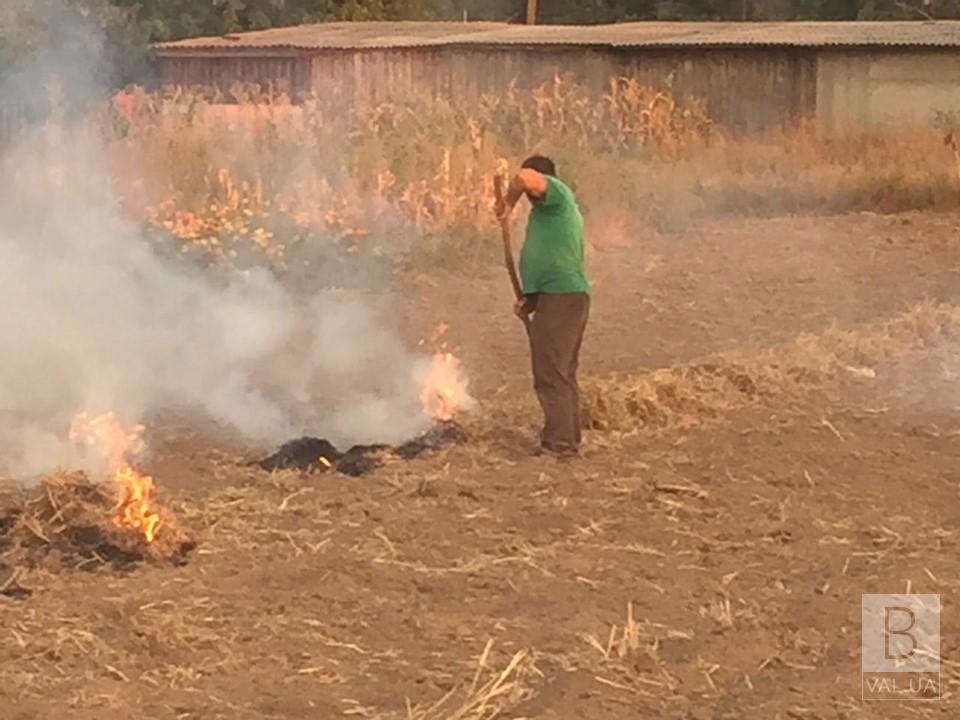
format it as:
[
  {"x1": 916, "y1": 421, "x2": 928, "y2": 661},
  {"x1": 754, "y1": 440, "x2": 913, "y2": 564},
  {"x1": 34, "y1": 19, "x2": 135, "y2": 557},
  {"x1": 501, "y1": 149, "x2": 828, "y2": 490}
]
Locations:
[{"x1": 498, "y1": 155, "x2": 590, "y2": 455}]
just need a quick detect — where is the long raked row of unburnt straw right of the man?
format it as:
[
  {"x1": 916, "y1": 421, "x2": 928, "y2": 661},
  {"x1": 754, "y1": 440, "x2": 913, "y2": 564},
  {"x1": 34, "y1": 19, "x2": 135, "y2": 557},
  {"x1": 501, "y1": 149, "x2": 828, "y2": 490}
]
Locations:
[{"x1": 540, "y1": 302, "x2": 960, "y2": 433}]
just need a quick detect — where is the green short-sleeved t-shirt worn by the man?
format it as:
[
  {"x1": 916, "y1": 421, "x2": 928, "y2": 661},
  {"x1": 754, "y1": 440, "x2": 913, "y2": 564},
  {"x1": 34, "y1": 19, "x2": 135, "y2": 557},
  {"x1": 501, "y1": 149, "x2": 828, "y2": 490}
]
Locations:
[{"x1": 520, "y1": 176, "x2": 590, "y2": 295}]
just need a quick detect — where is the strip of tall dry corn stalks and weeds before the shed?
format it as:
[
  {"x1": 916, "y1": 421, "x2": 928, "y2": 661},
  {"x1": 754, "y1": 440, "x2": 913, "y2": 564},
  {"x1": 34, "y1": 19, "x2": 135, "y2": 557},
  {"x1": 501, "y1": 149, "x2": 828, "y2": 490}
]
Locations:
[{"x1": 104, "y1": 78, "x2": 960, "y2": 272}]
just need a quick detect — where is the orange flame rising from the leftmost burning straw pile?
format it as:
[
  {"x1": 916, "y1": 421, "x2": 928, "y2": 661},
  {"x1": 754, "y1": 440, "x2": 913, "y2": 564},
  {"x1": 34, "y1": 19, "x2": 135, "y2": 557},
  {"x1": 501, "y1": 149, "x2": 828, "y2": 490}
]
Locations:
[{"x1": 70, "y1": 412, "x2": 161, "y2": 543}]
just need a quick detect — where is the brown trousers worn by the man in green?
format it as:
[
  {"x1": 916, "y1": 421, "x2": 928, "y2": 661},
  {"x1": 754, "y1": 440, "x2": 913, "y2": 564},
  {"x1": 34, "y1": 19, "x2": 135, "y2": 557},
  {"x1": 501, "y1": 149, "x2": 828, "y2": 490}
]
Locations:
[{"x1": 530, "y1": 293, "x2": 590, "y2": 452}]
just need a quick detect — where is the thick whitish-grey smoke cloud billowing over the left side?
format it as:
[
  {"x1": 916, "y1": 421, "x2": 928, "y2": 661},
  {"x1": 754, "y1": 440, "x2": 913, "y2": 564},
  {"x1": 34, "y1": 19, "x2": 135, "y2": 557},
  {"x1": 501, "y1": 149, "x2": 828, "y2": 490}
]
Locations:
[{"x1": 0, "y1": 0, "x2": 438, "y2": 484}]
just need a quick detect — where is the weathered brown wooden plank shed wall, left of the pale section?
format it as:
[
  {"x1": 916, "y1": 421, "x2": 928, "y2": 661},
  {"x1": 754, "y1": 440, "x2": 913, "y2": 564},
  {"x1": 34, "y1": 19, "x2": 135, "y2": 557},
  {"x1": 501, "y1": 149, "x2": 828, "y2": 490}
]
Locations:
[{"x1": 161, "y1": 46, "x2": 817, "y2": 132}]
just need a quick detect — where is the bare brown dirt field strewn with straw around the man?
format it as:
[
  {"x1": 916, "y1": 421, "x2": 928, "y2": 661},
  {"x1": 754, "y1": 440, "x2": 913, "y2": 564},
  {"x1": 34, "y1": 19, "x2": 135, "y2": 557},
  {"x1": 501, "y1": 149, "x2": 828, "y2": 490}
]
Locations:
[{"x1": 0, "y1": 214, "x2": 960, "y2": 720}]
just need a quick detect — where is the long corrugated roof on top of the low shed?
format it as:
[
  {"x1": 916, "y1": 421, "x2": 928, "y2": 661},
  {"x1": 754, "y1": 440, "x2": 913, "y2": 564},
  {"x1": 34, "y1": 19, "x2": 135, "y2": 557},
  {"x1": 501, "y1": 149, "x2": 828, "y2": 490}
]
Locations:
[{"x1": 155, "y1": 20, "x2": 960, "y2": 55}]
